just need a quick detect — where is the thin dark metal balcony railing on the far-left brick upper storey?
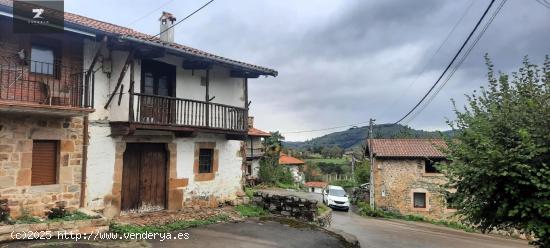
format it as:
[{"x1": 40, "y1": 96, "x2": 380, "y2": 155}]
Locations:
[{"x1": 0, "y1": 57, "x2": 93, "y2": 108}]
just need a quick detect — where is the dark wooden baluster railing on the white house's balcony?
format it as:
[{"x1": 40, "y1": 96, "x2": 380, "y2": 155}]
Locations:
[{"x1": 130, "y1": 93, "x2": 248, "y2": 132}]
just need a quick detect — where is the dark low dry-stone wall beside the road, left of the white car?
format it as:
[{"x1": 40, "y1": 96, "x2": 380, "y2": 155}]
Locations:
[{"x1": 252, "y1": 191, "x2": 318, "y2": 222}]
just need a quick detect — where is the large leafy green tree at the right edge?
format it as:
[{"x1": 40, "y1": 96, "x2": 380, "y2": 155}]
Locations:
[{"x1": 444, "y1": 56, "x2": 550, "y2": 247}]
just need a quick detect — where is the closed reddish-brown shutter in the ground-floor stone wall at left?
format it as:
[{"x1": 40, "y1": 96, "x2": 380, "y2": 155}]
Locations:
[{"x1": 31, "y1": 140, "x2": 59, "y2": 185}]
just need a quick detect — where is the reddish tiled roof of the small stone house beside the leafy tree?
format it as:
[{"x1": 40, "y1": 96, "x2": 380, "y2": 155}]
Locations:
[{"x1": 371, "y1": 139, "x2": 447, "y2": 158}]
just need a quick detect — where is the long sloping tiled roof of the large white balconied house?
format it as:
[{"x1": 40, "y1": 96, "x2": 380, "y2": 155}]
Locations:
[{"x1": 0, "y1": 0, "x2": 278, "y2": 76}]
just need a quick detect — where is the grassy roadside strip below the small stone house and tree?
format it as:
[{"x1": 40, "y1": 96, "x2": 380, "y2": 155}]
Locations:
[{"x1": 357, "y1": 202, "x2": 477, "y2": 232}]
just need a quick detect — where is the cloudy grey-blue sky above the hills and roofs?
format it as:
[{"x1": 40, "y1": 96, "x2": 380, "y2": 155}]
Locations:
[{"x1": 65, "y1": 0, "x2": 550, "y2": 140}]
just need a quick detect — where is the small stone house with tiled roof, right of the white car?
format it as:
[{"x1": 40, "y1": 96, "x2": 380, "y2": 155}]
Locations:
[{"x1": 368, "y1": 139, "x2": 454, "y2": 219}]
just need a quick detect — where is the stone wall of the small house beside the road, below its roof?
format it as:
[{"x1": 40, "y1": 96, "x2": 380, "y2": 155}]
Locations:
[{"x1": 373, "y1": 158, "x2": 454, "y2": 219}]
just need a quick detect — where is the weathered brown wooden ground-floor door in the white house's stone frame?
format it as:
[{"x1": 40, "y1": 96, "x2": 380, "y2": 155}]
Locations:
[{"x1": 121, "y1": 143, "x2": 167, "y2": 211}]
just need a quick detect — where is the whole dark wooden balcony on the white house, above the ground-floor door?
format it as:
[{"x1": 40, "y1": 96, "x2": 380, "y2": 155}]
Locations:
[{"x1": 111, "y1": 93, "x2": 248, "y2": 139}]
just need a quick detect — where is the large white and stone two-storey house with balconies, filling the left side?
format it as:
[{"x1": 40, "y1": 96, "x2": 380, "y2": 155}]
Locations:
[{"x1": 0, "y1": 0, "x2": 277, "y2": 217}]
